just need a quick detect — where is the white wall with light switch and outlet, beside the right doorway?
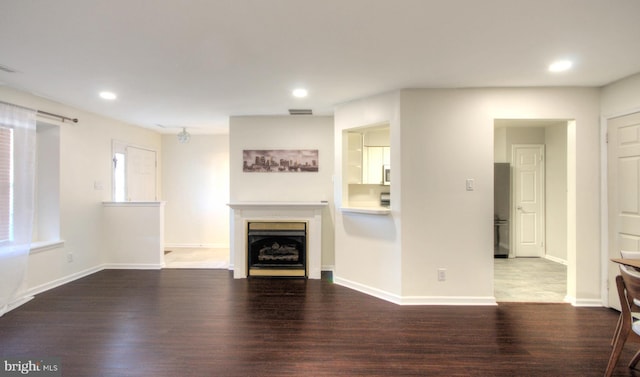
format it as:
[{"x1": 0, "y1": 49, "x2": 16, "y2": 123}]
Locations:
[{"x1": 400, "y1": 90, "x2": 495, "y2": 304}]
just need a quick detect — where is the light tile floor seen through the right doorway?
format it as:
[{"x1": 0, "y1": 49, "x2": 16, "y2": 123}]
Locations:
[{"x1": 493, "y1": 258, "x2": 567, "y2": 302}]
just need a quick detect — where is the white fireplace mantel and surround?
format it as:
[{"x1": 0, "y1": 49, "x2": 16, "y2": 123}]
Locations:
[{"x1": 227, "y1": 201, "x2": 328, "y2": 279}]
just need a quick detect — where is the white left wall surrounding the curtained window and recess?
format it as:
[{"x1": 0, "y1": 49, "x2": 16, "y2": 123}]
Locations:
[{"x1": 0, "y1": 87, "x2": 161, "y2": 291}]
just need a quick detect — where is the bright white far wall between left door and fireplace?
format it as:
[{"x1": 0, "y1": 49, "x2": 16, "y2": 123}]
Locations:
[{"x1": 162, "y1": 134, "x2": 229, "y2": 248}]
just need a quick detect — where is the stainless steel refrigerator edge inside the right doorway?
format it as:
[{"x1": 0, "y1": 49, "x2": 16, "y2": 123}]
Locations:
[{"x1": 493, "y1": 162, "x2": 511, "y2": 258}]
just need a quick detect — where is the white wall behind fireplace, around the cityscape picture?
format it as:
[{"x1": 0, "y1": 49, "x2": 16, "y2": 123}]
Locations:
[{"x1": 229, "y1": 116, "x2": 334, "y2": 268}]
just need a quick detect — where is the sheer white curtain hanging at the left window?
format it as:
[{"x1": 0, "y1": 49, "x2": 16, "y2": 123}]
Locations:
[{"x1": 0, "y1": 103, "x2": 37, "y2": 316}]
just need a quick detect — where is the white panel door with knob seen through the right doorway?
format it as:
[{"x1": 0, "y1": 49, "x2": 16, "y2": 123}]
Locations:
[{"x1": 512, "y1": 144, "x2": 545, "y2": 257}]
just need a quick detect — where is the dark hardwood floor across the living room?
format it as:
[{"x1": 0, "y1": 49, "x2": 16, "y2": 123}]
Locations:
[{"x1": 0, "y1": 270, "x2": 640, "y2": 377}]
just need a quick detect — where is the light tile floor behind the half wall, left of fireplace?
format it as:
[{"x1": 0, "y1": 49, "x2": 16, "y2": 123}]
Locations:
[{"x1": 164, "y1": 248, "x2": 229, "y2": 269}]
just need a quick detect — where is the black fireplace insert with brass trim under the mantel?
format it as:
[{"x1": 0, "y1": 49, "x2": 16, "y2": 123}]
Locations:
[{"x1": 247, "y1": 221, "x2": 307, "y2": 277}]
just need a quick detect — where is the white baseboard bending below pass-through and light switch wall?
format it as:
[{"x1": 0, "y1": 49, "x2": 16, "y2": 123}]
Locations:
[{"x1": 333, "y1": 276, "x2": 497, "y2": 306}]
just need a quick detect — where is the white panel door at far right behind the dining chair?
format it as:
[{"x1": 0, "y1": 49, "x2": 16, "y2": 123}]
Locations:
[{"x1": 607, "y1": 113, "x2": 640, "y2": 308}]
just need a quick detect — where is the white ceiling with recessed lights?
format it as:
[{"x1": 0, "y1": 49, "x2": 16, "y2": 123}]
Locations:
[{"x1": 0, "y1": 0, "x2": 640, "y2": 133}]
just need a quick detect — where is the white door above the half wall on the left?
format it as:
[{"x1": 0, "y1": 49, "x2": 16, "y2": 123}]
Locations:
[{"x1": 127, "y1": 146, "x2": 157, "y2": 202}]
